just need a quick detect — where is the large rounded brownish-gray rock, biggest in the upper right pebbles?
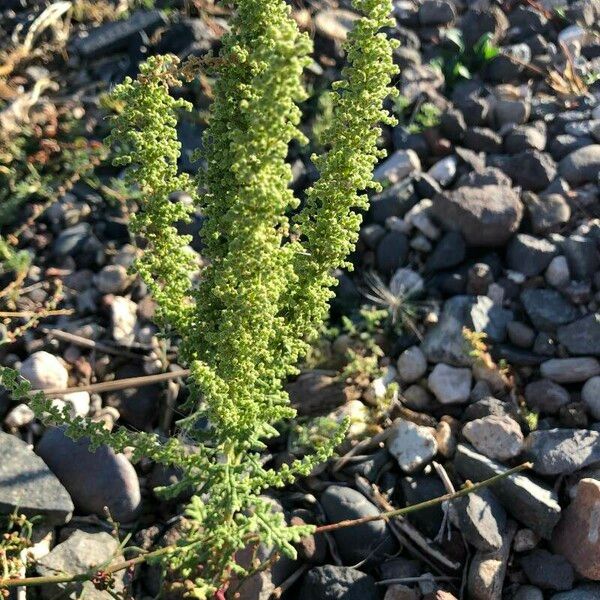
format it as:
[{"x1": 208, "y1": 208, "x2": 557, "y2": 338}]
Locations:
[{"x1": 431, "y1": 185, "x2": 523, "y2": 247}]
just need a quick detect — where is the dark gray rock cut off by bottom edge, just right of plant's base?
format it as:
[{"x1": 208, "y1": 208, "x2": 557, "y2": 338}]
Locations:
[{"x1": 298, "y1": 565, "x2": 379, "y2": 600}]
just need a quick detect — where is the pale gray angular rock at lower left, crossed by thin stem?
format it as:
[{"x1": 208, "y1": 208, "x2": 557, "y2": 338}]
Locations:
[{"x1": 35, "y1": 531, "x2": 125, "y2": 600}]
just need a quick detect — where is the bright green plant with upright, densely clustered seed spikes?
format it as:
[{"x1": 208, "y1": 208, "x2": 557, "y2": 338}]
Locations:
[{"x1": 4, "y1": 0, "x2": 395, "y2": 598}]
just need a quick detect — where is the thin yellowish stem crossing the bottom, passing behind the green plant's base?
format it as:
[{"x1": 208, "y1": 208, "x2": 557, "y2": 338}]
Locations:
[{"x1": 0, "y1": 462, "x2": 533, "y2": 589}]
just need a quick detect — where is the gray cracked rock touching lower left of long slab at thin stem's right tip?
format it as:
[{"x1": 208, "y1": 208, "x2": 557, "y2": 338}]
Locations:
[{"x1": 451, "y1": 489, "x2": 506, "y2": 552}]
